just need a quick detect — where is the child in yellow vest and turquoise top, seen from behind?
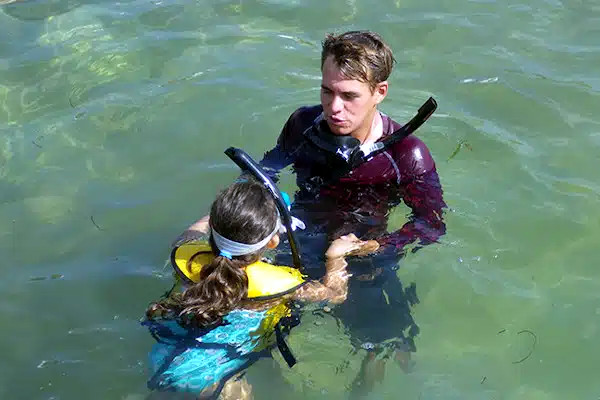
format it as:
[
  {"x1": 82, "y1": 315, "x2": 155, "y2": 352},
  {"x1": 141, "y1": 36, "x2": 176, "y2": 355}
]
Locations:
[{"x1": 144, "y1": 180, "x2": 379, "y2": 399}]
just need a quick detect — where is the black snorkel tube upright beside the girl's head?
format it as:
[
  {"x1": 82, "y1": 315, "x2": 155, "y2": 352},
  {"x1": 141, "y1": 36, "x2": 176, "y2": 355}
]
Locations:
[{"x1": 225, "y1": 147, "x2": 302, "y2": 270}]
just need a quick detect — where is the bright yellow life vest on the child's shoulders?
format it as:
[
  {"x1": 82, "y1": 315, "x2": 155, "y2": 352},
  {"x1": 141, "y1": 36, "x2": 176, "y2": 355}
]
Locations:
[{"x1": 171, "y1": 242, "x2": 305, "y2": 300}]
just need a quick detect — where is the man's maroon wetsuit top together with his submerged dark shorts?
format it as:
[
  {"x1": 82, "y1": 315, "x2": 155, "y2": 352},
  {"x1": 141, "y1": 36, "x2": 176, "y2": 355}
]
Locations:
[{"x1": 261, "y1": 106, "x2": 446, "y2": 351}]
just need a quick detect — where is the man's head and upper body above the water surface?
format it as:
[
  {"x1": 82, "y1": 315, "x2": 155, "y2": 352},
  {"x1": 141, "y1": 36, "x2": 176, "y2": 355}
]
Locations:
[{"x1": 261, "y1": 31, "x2": 446, "y2": 260}]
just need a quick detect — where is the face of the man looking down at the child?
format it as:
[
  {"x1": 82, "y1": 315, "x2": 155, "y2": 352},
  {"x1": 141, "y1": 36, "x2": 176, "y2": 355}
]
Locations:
[{"x1": 321, "y1": 56, "x2": 387, "y2": 140}]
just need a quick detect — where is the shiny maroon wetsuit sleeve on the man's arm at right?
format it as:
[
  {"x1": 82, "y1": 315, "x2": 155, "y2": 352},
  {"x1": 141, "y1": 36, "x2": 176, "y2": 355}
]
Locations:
[{"x1": 379, "y1": 138, "x2": 446, "y2": 250}]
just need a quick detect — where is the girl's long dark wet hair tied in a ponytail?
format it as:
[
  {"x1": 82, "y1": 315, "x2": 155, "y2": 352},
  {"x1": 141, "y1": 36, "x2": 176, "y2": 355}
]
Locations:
[{"x1": 146, "y1": 178, "x2": 278, "y2": 327}]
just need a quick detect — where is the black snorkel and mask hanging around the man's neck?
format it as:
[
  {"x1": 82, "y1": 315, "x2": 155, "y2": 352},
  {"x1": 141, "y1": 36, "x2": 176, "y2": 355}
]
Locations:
[{"x1": 304, "y1": 97, "x2": 437, "y2": 178}]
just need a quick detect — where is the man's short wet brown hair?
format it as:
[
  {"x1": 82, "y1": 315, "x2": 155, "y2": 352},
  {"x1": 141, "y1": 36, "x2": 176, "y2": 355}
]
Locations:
[{"x1": 321, "y1": 31, "x2": 396, "y2": 91}]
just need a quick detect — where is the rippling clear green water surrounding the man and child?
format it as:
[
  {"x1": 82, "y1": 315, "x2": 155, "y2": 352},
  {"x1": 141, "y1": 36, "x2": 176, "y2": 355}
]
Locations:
[{"x1": 0, "y1": 0, "x2": 600, "y2": 400}]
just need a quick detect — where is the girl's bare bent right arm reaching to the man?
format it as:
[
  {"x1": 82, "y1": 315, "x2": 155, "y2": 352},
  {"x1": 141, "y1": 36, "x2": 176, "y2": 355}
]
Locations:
[{"x1": 292, "y1": 233, "x2": 379, "y2": 304}]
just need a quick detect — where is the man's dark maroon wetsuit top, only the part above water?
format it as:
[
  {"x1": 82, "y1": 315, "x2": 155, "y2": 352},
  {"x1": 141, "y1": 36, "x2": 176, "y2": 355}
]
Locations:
[{"x1": 261, "y1": 106, "x2": 446, "y2": 250}]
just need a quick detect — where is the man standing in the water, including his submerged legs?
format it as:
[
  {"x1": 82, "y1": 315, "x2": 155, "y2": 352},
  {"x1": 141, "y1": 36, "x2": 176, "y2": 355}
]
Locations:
[{"x1": 261, "y1": 31, "x2": 446, "y2": 396}]
